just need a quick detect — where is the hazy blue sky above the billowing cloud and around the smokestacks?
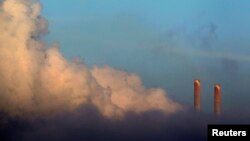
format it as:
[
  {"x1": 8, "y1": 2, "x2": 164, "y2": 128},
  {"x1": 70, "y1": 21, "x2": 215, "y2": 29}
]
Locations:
[{"x1": 42, "y1": 0, "x2": 250, "y2": 113}]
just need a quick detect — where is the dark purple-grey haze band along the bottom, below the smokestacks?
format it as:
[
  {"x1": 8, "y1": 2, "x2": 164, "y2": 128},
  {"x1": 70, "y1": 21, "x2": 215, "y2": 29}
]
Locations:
[{"x1": 0, "y1": 107, "x2": 249, "y2": 141}]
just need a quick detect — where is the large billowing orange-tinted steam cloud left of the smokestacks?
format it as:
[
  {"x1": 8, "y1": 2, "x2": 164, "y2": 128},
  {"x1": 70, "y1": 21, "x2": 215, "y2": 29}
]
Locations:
[{"x1": 0, "y1": 0, "x2": 182, "y2": 118}]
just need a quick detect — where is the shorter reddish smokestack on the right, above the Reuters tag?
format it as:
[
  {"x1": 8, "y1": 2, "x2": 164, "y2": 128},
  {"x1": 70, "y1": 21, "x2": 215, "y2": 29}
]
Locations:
[{"x1": 214, "y1": 84, "x2": 221, "y2": 115}]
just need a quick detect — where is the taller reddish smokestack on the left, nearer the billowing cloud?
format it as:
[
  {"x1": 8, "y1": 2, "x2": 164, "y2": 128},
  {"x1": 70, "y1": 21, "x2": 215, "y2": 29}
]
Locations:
[{"x1": 194, "y1": 79, "x2": 201, "y2": 112}]
